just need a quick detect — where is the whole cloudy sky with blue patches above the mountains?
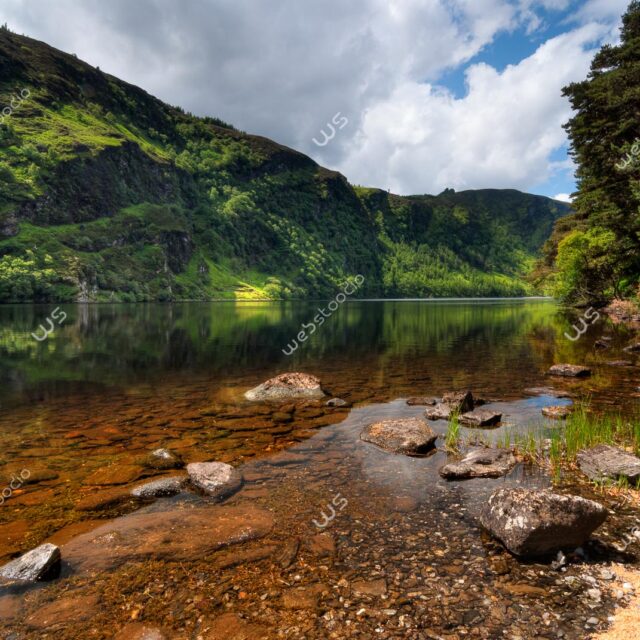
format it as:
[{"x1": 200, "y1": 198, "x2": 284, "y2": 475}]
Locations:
[{"x1": 0, "y1": 0, "x2": 628, "y2": 200}]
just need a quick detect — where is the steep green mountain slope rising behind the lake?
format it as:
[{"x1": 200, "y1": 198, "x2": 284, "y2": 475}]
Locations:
[{"x1": 0, "y1": 29, "x2": 570, "y2": 301}]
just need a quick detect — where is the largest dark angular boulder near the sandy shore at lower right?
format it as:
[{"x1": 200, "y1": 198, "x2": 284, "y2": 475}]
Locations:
[{"x1": 480, "y1": 488, "x2": 607, "y2": 557}]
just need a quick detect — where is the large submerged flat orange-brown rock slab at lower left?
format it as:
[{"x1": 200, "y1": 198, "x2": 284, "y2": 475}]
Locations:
[{"x1": 62, "y1": 505, "x2": 274, "y2": 571}]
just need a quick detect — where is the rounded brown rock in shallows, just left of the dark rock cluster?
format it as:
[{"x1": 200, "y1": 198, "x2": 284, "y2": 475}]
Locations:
[{"x1": 360, "y1": 418, "x2": 438, "y2": 455}]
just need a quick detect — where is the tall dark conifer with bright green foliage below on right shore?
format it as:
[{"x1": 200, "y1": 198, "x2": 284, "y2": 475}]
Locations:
[{"x1": 534, "y1": 1, "x2": 640, "y2": 304}]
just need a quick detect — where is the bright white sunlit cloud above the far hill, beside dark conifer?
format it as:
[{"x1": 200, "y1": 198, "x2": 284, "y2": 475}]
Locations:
[{"x1": 340, "y1": 25, "x2": 603, "y2": 193}]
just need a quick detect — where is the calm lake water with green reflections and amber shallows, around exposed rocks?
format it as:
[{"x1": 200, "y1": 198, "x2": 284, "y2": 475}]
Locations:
[{"x1": 0, "y1": 299, "x2": 639, "y2": 638}]
